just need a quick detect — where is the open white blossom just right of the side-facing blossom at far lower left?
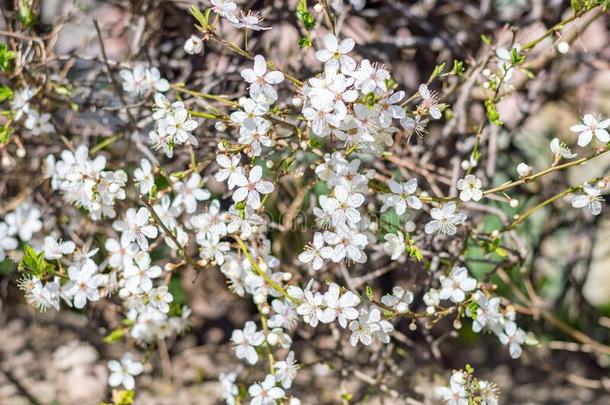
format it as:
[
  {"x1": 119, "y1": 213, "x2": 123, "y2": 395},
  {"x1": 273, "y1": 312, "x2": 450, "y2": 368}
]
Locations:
[{"x1": 63, "y1": 262, "x2": 103, "y2": 309}]
